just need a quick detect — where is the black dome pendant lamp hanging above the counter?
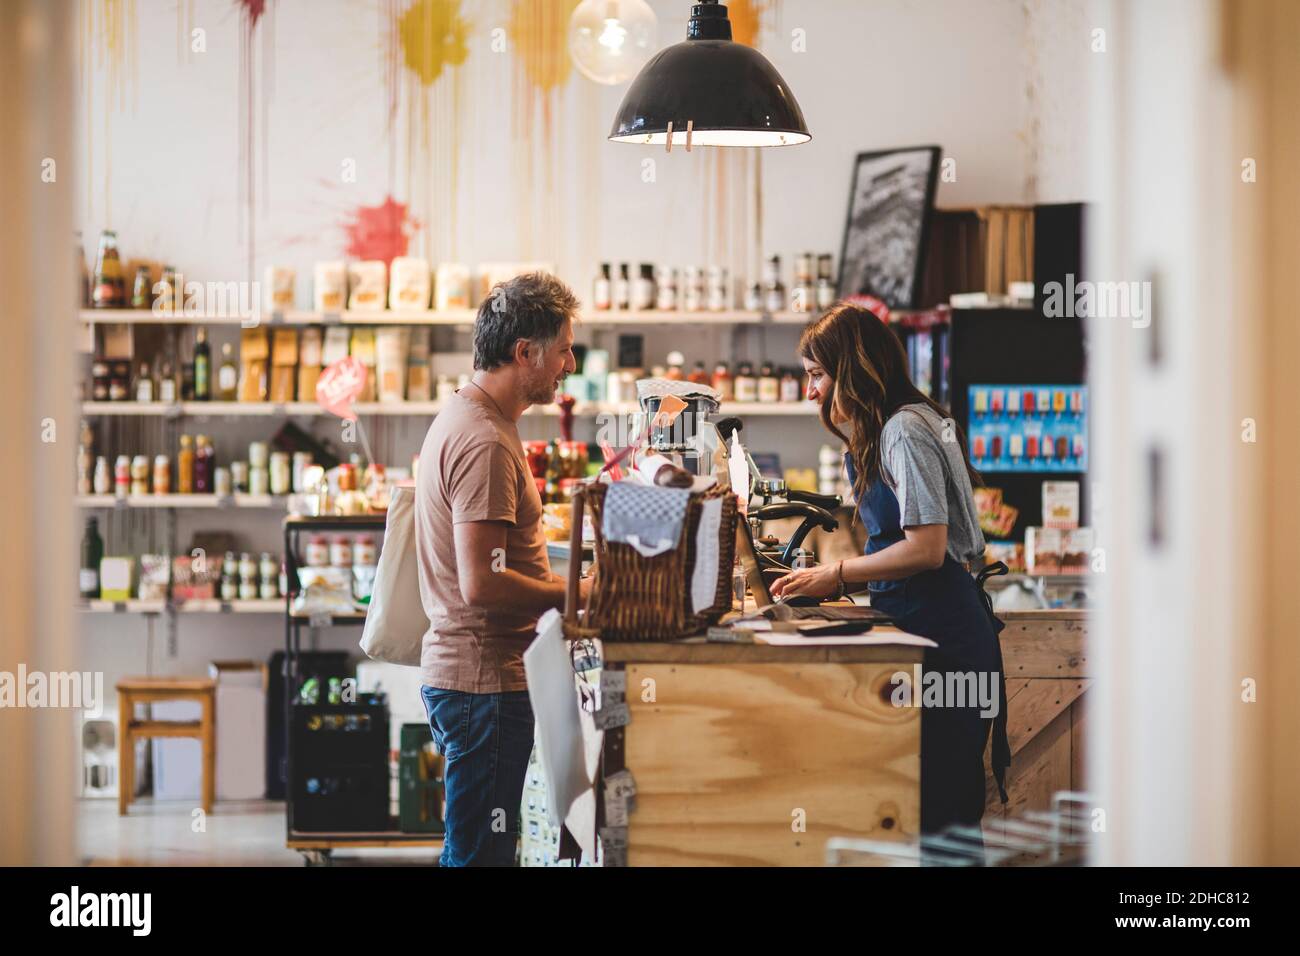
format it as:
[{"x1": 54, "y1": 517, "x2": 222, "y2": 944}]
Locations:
[{"x1": 610, "y1": 0, "x2": 813, "y2": 148}]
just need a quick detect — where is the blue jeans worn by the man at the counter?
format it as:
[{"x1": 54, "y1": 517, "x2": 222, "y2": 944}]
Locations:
[{"x1": 420, "y1": 685, "x2": 533, "y2": 866}]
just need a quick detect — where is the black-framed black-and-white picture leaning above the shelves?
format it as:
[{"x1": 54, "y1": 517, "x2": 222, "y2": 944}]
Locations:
[{"x1": 839, "y1": 146, "x2": 940, "y2": 308}]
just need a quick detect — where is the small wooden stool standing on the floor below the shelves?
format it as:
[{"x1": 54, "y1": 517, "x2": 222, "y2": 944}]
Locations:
[{"x1": 117, "y1": 678, "x2": 217, "y2": 817}]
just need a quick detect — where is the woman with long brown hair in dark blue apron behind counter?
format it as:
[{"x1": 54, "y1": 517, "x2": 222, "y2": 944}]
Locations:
[{"x1": 772, "y1": 303, "x2": 1010, "y2": 832}]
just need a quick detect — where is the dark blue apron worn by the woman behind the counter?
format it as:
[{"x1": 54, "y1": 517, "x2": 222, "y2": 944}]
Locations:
[{"x1": 845, "y1": 455, "x2": 1011, "y2": 834}]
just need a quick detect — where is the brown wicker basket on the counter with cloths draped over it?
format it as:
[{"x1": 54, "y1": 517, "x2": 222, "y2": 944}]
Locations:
[{"x1": 564, "y1": 484, "x2": 736, "y2": 641}]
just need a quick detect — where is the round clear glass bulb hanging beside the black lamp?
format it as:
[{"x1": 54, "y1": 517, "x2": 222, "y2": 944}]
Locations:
[{"x1": 569, "y1": 0, "x2": 659, "y2": 86}]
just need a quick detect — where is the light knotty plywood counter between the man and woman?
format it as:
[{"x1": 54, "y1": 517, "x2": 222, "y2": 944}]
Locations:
[{"x1": 603, "y1": 628, "x2": 923, "y2": 866}]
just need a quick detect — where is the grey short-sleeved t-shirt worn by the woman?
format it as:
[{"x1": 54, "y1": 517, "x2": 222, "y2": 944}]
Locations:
[{"x1": 880, "y1": 405, "x2": 984, "y2": 563}]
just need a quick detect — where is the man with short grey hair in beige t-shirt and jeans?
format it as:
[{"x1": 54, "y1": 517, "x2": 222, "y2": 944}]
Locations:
[{"x1": 415, "y1": 273, "x2": 587, "y2": 866}]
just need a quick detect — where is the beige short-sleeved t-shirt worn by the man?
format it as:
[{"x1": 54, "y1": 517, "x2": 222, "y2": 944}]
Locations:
[{"x1": 415, "y1": 385, "x2": 551, "y2": 693}]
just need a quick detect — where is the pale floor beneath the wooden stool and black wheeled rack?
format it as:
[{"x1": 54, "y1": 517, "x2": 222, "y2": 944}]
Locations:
[{"x1": 77, "y1": 799, "x2": 437, "y2": 866}]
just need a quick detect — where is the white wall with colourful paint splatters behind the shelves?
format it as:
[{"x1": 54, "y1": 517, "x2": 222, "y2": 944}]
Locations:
[{"x1": 78, "y1": 0, "x2": 1086, "y2": 712}]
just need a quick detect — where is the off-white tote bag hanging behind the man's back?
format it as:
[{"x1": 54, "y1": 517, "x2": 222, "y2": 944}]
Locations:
[{"x1": 361, "y1": 486, "x2": 429, "y2": 667}]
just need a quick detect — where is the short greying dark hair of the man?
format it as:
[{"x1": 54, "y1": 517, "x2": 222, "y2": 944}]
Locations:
[{"x1": 475, "y1": 272, "x2": 577, "y2": 371}]
